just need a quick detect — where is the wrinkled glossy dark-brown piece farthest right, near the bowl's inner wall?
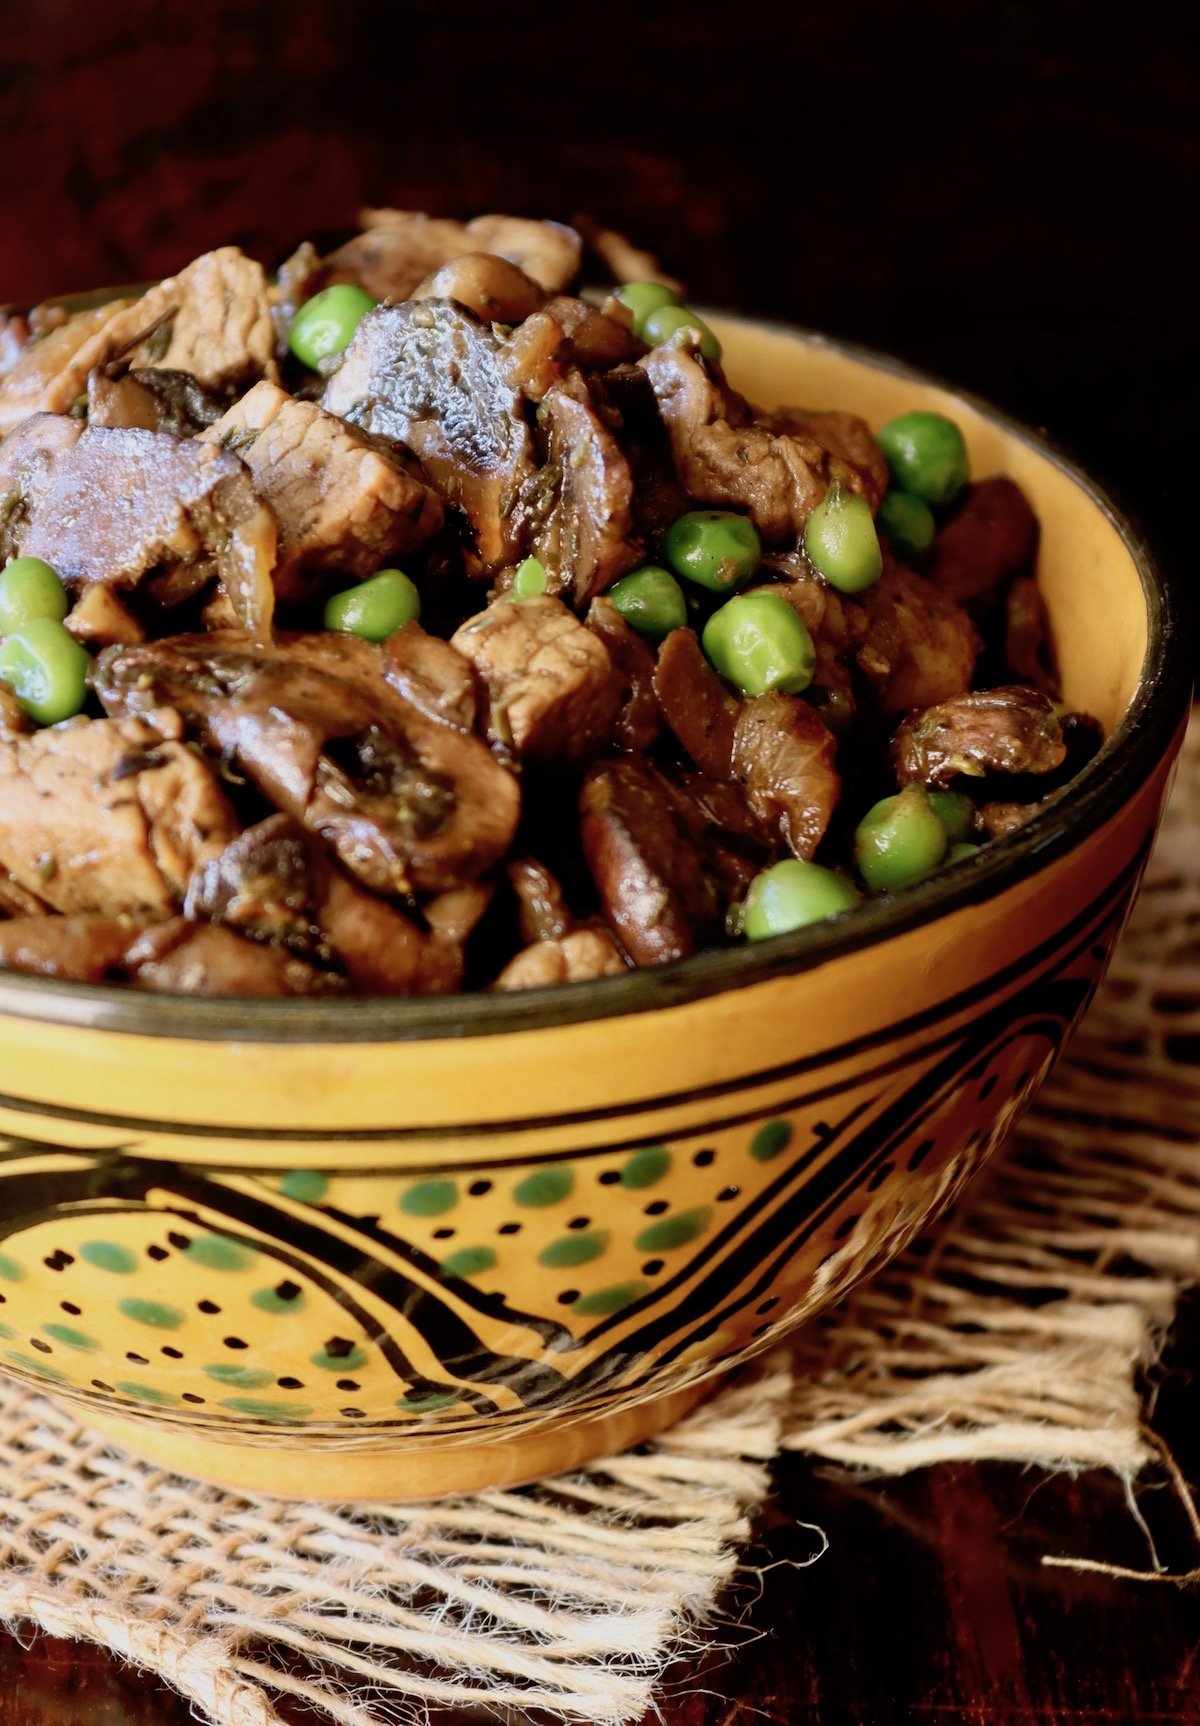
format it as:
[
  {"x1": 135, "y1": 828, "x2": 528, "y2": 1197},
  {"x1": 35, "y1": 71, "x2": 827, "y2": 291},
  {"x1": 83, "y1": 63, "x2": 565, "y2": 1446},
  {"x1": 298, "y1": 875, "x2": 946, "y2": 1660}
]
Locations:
[{"x1": 891, "y1": 683, "x2": 1067, "y2": 785}]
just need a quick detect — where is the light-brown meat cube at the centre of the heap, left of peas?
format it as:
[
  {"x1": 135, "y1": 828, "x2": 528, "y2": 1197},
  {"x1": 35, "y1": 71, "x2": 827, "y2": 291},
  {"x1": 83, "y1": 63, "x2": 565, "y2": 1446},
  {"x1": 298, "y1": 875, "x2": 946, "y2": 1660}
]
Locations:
[{"x1": 451, "y1": 597, "x2": 622, "y2": 766}]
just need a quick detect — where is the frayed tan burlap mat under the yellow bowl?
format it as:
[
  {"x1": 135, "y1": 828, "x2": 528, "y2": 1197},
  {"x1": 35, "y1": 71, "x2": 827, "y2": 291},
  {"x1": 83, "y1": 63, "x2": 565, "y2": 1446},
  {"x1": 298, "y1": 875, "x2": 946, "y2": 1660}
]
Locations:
[{"x1": 0, "y1": 723, "x2": 1200, "y2": 1726}]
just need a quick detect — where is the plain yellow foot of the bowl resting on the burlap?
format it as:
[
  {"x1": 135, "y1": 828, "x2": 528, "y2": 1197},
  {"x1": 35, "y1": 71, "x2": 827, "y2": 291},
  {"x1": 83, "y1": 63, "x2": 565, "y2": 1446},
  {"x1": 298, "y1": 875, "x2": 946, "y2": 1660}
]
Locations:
[{"x1": 75, "y1": 1377, "x2": 720, "y2": 1503}]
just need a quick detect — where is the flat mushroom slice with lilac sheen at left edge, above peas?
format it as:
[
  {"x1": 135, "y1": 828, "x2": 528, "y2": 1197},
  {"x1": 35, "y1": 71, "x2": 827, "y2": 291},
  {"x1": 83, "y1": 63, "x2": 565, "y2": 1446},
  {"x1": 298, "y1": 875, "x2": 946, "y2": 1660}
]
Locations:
[{"x1": 0, "y1": 416, "x2": 275, "y2": 633}]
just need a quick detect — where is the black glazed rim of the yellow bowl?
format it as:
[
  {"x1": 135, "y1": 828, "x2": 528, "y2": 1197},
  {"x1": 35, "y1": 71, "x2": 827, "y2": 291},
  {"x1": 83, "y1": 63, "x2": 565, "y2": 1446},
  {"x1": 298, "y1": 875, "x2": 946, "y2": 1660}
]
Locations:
[{"x1": 0, "y1": 312, "x2": 1191, "y2": 1043}]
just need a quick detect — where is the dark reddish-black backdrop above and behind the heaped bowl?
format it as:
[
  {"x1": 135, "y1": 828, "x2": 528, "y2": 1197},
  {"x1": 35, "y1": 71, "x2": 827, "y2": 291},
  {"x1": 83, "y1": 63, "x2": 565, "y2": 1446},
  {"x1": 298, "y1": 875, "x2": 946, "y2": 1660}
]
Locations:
[{"x1": 0, "y1": 0, "x2": 1200, "y2": 597}]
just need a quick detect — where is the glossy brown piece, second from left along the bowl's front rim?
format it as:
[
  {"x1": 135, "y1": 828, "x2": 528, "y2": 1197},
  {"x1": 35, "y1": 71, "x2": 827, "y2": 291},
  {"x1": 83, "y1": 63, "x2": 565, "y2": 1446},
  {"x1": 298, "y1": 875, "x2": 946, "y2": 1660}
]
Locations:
[{"x1": 124, "y1": 917, "x2": 345, "y2": 999}]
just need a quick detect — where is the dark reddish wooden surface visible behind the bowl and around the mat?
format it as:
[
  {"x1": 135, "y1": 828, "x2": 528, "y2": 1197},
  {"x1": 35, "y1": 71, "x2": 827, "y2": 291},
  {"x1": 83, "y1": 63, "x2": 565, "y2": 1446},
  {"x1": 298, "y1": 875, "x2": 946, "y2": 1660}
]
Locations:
[{"x1": 0, "y1": 0, "x2": 1200, "y2": 1726}]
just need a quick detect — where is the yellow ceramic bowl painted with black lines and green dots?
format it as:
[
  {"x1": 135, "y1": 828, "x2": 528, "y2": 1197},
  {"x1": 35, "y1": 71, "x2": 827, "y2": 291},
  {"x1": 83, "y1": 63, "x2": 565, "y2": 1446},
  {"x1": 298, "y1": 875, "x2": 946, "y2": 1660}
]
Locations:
[{"x1": 0, "y1": 319, "x2": 1186, "y2": 1498}]
